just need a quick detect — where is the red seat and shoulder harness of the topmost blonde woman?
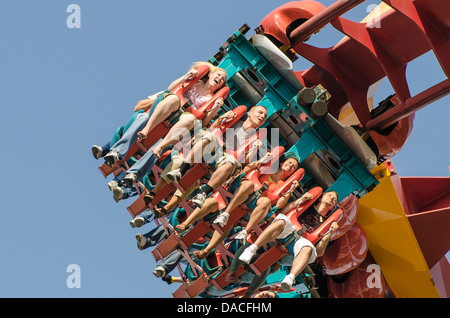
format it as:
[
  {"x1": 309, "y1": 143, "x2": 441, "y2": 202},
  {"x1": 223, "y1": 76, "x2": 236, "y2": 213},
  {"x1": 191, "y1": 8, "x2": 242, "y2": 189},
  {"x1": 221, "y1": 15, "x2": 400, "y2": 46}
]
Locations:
[{"x1": 99, "y1": 65, "x2": 230, "y2": 177}]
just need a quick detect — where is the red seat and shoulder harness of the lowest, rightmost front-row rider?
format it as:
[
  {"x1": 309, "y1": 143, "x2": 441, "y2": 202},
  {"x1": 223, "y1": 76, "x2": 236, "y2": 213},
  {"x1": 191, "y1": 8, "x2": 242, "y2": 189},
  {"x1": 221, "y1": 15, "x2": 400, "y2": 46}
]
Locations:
[{"x1": 250, "y1": 187, "x2": 342, "y2": 275}]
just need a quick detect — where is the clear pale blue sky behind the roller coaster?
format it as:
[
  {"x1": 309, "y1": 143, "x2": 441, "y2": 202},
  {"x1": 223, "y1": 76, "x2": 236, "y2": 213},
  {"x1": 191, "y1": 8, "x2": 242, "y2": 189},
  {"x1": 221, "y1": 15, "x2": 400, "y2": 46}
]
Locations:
[{"x1": 0, "y1": 0, "x2": 450, "y2": 297}]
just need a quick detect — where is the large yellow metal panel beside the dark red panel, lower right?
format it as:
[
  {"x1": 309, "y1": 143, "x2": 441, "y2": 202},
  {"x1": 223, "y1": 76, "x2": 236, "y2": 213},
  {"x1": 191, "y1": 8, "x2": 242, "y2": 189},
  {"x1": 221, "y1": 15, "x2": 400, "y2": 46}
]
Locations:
[{"x1": 357, "y1": 164, "x2": 439, "y2": 298}]
